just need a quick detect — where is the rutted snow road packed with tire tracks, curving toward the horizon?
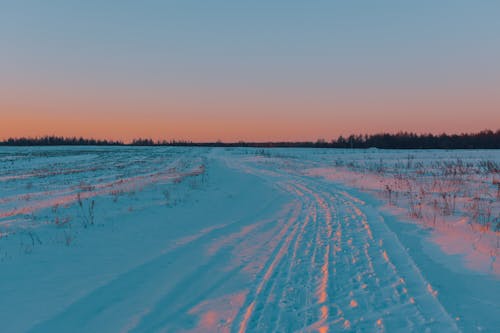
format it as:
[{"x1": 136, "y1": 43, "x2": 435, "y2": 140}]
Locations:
[{"x1": 218, "y1": 152, "x2": 457, "y2": 332}]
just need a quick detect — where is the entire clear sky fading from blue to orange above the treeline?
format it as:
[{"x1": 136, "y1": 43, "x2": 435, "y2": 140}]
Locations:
[{"x1": 0, "y1": 0, "x2": 500, "y2": 141}]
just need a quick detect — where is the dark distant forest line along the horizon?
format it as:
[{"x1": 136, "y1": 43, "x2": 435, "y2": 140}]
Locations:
[{"x1": 0, "y1": 130, "x2": 500, "y2": 149}]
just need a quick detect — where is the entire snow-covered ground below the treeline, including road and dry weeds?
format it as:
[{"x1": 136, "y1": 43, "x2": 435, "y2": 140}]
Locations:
[{"x1": 0, "y1": 147, "x2": 500, "y2": 332}]
